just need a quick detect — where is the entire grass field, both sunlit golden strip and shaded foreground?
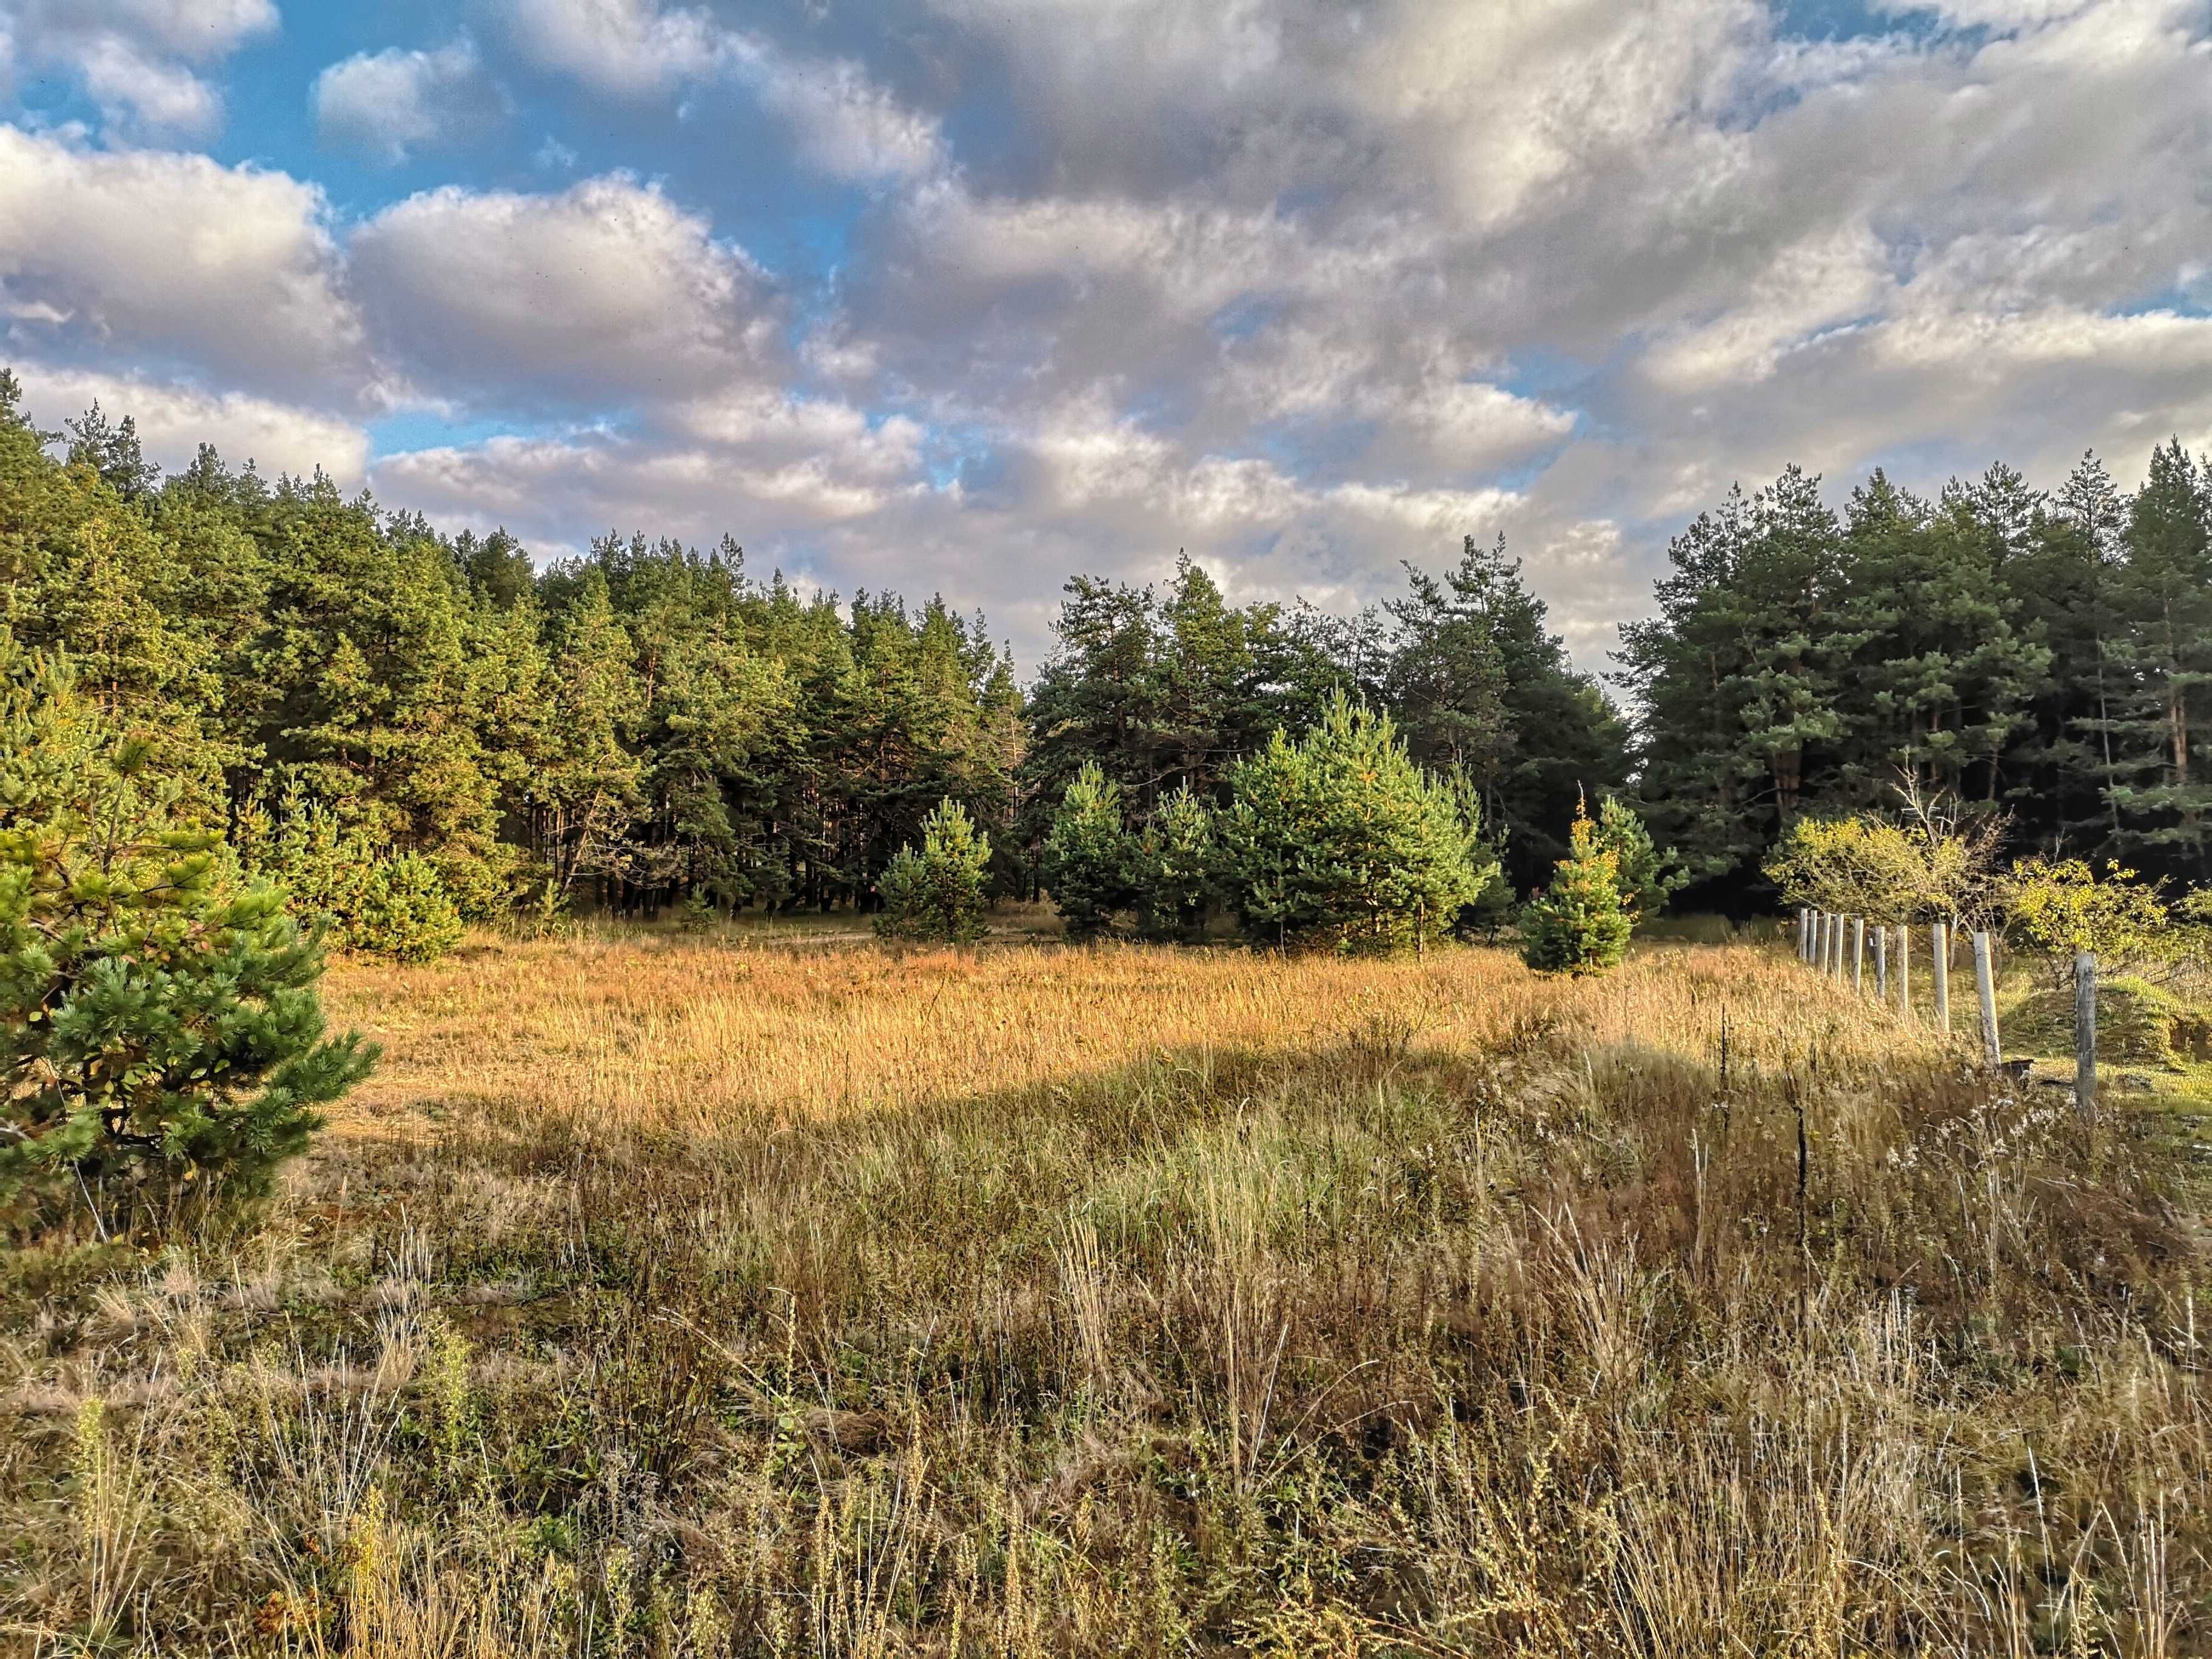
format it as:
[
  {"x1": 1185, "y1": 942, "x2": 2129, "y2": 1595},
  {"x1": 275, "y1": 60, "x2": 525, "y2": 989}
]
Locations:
[{"x1": 0, "y1": 929, "x2": 2212, "y2": 1659}]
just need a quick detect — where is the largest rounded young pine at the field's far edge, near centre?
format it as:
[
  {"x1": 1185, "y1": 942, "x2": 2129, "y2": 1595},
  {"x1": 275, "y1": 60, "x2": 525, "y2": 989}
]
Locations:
[{"x1": 1215, "y1": 694, "x2": 1489, "y2": 951}]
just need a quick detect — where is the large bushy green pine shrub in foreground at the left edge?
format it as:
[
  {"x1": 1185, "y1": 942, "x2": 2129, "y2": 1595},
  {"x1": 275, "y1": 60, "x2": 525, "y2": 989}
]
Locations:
[{"x1": 0, "y1": 641, "x2": 372, "y2": 1225}]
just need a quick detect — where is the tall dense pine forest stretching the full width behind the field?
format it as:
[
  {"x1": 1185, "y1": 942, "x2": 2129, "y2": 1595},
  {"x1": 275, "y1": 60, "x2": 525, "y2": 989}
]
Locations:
[{"x1": 0, "y1": 367, "x2": 2212, "y2": 918}]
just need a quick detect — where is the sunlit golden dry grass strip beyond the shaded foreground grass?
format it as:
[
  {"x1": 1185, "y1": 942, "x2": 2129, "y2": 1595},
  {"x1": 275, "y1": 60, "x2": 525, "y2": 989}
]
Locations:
[{"x1": 327, "y1": 933, "x2": 1925, "y2": 1134}]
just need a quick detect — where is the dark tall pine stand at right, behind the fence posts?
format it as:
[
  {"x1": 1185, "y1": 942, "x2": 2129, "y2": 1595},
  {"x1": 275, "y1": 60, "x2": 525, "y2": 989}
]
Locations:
[{"x1": 1619, "y1": 440, "x2": 2212, "y2": 902}]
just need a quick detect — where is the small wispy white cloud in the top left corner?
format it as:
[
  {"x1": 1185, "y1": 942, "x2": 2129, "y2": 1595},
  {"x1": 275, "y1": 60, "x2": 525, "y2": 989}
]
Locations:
[{"x1": 0, "y1": 0, "x2": 276, "y2": 137}]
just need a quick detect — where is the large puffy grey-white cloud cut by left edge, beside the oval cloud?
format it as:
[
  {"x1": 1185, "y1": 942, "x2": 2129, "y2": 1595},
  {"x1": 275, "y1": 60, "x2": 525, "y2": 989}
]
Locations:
[{"x1": 0, "y1": 126, "x2": 369, "y2": 396}]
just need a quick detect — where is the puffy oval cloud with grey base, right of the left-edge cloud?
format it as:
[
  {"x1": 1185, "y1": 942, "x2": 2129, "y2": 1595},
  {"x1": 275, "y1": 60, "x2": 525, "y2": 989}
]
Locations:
[{"x1": 352, "y1": 175, "x2": 776, "y2": 407}]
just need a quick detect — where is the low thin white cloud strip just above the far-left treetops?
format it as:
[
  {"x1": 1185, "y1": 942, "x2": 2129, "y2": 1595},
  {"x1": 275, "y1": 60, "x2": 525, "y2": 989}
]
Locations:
[{"x1": 16, "y1": 363, "x2": 369, "y2": 487}]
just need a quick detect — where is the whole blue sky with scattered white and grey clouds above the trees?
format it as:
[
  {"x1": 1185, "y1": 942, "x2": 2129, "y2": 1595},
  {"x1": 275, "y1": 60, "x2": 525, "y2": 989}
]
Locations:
[{"x1": 0, "y1": 0, "x2": 2212, "y2": 670}]
